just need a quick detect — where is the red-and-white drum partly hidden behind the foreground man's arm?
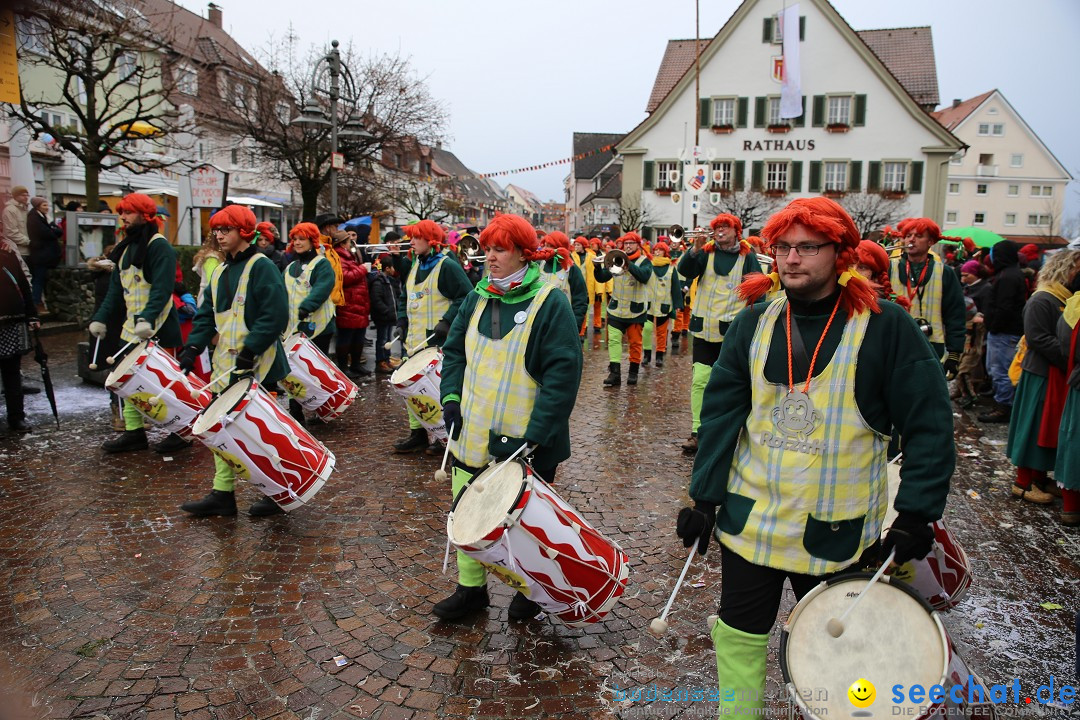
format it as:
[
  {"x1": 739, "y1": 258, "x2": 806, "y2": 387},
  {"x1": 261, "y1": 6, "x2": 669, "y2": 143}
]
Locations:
[{"x1": 881, "y1": 463, "x2": 972, "y2": 611}]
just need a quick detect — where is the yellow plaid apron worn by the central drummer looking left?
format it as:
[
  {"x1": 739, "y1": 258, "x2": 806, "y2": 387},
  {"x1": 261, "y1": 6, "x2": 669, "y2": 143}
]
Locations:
[{"x1": 450, "y1": 284, "x2": 555, "y2": 467}]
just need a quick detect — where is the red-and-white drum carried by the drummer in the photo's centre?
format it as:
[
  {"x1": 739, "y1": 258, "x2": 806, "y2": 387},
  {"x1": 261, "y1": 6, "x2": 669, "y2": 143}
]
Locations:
[{"x1": 446, "y1": 461, "x2": 630, "y2": 627}]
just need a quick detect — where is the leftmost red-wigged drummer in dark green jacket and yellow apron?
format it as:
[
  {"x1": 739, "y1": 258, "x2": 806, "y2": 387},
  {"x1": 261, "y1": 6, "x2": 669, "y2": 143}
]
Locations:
[{"x1": 89, "y1": 192, "x2": 184, "y2": 452}]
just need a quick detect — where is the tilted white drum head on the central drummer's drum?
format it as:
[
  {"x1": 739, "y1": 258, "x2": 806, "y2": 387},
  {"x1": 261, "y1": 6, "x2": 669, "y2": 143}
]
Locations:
[{"x1": 450, "y1": 462, "x2": 525, "y2": 545}]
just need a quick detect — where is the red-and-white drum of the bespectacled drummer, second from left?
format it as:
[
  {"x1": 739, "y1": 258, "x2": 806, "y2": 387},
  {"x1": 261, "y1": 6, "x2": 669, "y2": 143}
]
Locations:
[{"x1": 192, "y1": 378, "x2": 337, "y2": 511}]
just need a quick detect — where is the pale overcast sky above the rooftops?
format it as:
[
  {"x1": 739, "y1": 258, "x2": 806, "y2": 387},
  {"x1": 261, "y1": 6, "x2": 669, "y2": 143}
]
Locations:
[{"x1": 179, "y1": 0, "x2": 1080, "y2": 216}]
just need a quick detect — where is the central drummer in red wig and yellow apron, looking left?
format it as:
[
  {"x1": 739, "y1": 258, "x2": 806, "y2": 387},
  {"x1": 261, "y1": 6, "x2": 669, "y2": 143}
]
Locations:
[{"x1": 434, "y1": 215, "x2": 582, "y2": 620}]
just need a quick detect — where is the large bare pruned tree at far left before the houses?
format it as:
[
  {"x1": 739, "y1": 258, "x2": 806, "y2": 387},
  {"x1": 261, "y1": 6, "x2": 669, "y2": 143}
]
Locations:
[{"x1": 4, "y1": 0, "x2": 186, "y2": 208}]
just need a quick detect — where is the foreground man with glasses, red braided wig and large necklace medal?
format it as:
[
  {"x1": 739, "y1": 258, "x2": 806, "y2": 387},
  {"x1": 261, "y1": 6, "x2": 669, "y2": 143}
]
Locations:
[{"x1": 676, "y1": 198, "x2": 956, "y2": 716}]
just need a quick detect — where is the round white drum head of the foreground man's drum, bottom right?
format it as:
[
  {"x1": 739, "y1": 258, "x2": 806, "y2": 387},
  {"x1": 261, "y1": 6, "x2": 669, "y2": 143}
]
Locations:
[{"x1": 780, "y1": 573, "x2": 949, "y2": 718}]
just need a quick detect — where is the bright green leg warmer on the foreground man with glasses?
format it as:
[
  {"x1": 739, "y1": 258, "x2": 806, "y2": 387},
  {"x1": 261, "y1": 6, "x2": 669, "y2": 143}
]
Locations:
[{"x1": 712, "y1": 619, "x2": 769, "y2": 718}]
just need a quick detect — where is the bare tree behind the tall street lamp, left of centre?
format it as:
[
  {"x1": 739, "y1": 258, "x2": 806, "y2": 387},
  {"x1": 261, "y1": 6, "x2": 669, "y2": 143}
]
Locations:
[{"x1": 240, "y1": 33, "x2": 447, "y2": 217}]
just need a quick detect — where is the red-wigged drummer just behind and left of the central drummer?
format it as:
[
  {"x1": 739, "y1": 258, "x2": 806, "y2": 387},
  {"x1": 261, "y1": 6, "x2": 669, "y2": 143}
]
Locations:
[{"x1": 394, "y1": 220, "x2": 472, "y2": 456}]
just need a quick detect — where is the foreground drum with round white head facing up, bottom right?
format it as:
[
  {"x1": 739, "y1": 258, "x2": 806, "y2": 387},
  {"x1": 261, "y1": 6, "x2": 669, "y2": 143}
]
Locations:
[{"x1": 780, "y1": 573, "x2": 997, "y2": 720}]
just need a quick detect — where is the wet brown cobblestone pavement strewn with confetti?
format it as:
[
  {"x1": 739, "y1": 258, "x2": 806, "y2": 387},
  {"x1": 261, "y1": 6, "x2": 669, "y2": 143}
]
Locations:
[{"x1": 0, "y1": 334, "x2": 1080, "y2": 720}]
